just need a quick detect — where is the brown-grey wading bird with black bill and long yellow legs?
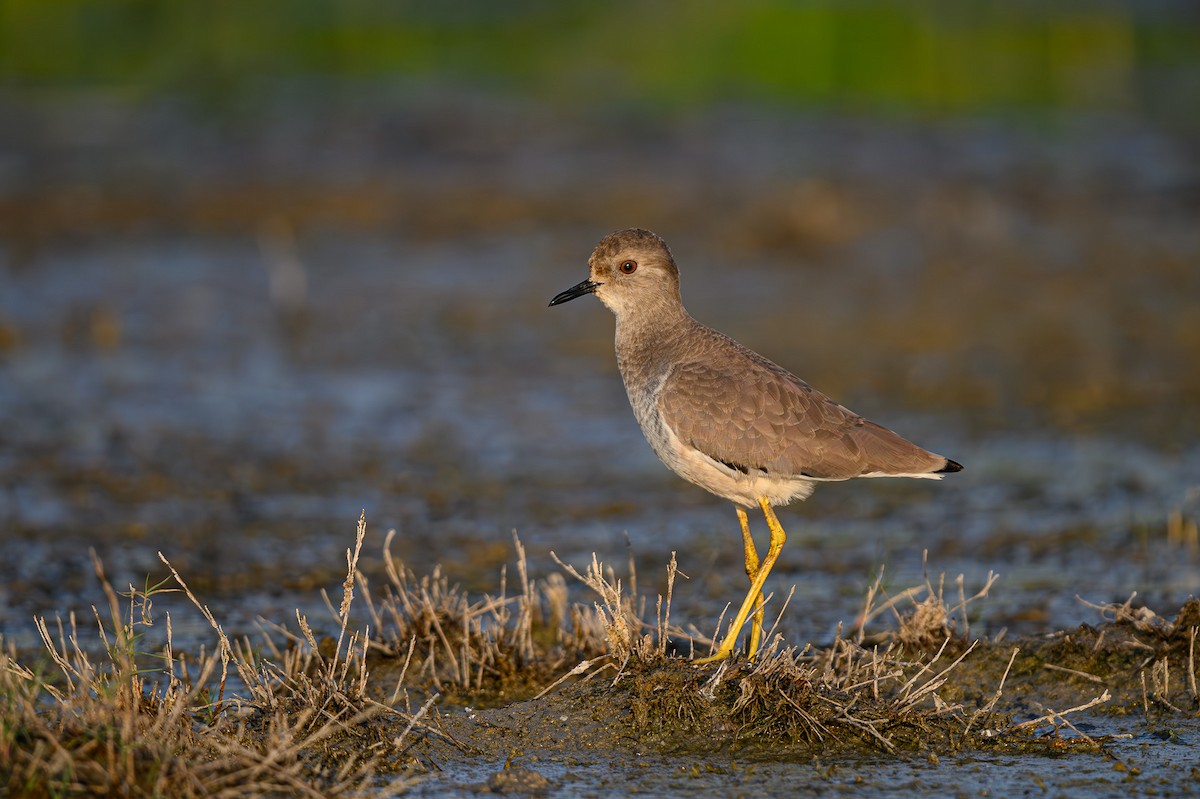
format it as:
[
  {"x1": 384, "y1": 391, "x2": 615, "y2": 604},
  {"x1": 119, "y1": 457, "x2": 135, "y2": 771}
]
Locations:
[{"x1": 550, "y1": 228, "x2": 962, "y2": 663}]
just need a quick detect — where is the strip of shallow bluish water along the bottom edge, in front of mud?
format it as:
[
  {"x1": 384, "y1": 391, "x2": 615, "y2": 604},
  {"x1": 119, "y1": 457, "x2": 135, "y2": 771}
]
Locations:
[{"x1": 412, "y1": 720, "x2": 1200, "y2": 798}]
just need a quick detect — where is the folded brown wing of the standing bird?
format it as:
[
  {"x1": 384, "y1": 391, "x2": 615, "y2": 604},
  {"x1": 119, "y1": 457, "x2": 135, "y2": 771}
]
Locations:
[{"x1": 659, "y1": 352, "x2": 946, "y2": 480}]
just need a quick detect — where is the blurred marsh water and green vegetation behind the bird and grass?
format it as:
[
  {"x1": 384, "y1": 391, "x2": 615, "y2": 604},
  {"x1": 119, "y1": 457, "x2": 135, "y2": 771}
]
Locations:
[{"x1": 0, "y1": 0, "x2": 1200, "y2": 639}]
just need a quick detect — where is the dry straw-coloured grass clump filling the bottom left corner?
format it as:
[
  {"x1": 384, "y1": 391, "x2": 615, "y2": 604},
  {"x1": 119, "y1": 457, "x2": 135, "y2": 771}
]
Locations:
[{"x1": 0, "y1": 519, "x2": 427, "y2": 798}]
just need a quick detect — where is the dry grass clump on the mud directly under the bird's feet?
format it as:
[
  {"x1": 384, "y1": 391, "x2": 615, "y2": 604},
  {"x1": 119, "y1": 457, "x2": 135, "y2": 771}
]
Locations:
[{"x1": 552, "y1": 560, "x2": 1008, "y2": 751}]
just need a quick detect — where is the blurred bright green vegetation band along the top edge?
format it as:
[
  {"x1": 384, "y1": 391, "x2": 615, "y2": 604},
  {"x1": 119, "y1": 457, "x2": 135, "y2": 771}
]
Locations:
[{"x1": 0, "y1": 0, "x2": 1200, "y2": 126}]
